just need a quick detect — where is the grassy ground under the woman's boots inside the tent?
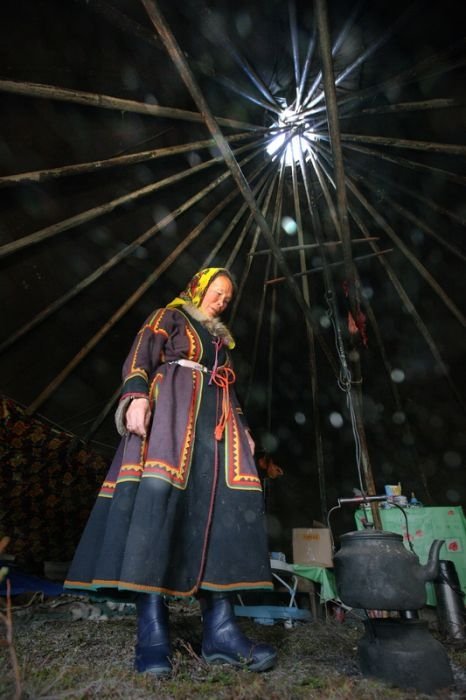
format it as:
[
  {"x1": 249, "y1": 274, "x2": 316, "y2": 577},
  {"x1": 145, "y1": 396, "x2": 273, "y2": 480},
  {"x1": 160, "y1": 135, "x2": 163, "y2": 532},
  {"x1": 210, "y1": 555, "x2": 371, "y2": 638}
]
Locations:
[{"x1": 0, "y1": 596, "x2": 466, "y2": 700}]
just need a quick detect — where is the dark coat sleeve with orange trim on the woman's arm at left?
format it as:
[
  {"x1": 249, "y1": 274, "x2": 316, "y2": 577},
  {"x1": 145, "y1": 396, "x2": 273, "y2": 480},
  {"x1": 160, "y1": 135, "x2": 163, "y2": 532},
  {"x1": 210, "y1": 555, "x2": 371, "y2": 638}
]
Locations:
[{"x1": 115, "y1": 309, "x2": 173, "y2": 435}]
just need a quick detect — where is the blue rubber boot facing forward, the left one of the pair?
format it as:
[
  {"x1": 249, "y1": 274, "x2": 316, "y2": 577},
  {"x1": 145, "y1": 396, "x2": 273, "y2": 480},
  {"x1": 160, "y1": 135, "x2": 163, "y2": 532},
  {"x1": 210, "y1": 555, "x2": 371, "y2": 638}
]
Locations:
[{"x1": 134, "y1": 593, "x2": 172, "y2": 676}]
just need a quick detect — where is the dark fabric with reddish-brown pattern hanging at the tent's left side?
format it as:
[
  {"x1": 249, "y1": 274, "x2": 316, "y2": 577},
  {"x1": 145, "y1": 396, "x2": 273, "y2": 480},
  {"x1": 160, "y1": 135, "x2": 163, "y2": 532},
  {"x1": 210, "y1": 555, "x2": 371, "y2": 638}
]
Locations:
[{"x1": 0, "y1": 398, "x2": 109, "y2": 573}]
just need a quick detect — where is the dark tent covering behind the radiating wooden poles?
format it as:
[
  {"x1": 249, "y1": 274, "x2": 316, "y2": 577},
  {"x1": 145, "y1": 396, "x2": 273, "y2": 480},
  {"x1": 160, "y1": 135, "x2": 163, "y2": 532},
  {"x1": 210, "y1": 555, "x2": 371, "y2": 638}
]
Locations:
[{"x1": 0, "y1": 0, "x2": 466, "y2": 544}]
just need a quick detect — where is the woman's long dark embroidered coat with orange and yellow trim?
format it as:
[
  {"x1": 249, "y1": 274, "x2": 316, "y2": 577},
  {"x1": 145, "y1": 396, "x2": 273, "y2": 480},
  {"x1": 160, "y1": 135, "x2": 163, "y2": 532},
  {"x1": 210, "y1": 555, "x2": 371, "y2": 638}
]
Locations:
[{"x1": 65, "y1": 305, "x2": 272, "y2": 596}]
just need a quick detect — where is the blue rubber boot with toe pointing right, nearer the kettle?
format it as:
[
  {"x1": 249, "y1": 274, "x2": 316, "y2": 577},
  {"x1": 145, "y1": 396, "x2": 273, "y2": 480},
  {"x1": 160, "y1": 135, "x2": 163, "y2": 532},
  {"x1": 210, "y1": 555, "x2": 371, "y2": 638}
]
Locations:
[{"x1": 200, "y1": 592, "x2": 277, "y2": 671}]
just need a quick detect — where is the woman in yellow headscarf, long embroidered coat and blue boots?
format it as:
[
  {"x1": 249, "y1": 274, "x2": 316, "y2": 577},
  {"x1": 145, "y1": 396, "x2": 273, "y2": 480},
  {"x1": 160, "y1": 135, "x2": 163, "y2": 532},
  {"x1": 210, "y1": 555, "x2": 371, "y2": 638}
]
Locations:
[{"x1": 65, "y1": 268, "x2": 276, "y2": 674}]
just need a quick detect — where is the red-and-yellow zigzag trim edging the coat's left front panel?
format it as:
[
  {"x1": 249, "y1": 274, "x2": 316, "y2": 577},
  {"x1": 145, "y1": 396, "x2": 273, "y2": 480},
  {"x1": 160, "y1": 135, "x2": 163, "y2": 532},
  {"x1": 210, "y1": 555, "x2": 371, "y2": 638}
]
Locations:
[{"x1": 143, "y1": 370, "x2": 203, "y2": 490}]
